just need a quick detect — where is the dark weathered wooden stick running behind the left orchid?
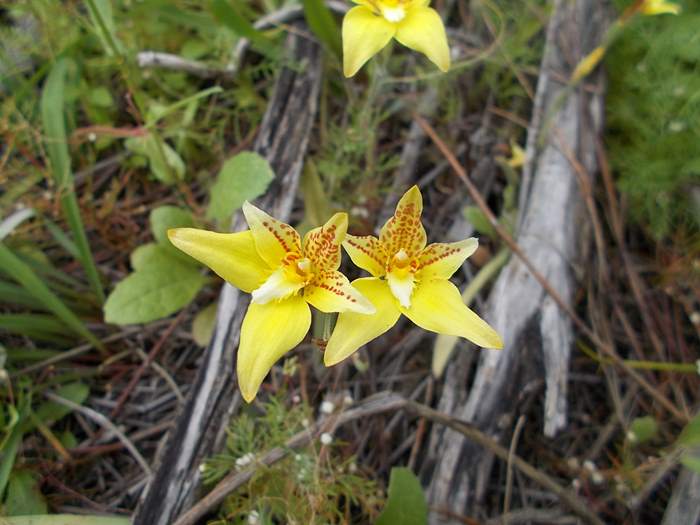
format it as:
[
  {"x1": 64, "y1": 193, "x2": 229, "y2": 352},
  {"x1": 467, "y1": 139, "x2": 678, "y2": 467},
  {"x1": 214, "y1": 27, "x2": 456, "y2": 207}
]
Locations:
[{"x1": 134, "y1": 34, "x2": 321, "y2": 525}]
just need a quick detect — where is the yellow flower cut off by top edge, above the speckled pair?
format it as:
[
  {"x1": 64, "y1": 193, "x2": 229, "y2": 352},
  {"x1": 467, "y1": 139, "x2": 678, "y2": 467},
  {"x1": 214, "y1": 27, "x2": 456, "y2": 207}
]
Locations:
[{"x1": 343, "y1": 0, "x2": 450, "y2": 77}]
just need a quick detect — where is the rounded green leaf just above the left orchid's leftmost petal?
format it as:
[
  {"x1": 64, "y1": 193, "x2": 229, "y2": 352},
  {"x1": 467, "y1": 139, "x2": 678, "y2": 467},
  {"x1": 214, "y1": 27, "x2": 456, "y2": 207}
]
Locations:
[{"x1": 207, "y1": 151, "x2": 275, "y2": 222}]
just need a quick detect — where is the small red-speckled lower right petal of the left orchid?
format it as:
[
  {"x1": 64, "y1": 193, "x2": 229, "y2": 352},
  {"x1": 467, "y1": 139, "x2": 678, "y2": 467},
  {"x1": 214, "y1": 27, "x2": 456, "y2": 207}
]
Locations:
[{"x1": 304, "y1": 271, "x2": 376, "y2": 314}]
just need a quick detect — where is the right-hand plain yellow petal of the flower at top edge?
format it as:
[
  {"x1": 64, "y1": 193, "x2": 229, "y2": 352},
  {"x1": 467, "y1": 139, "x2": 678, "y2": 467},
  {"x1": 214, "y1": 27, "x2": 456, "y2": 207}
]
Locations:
[{"x1": 396, "y1": 7, "x2": 450, "y2": 72}]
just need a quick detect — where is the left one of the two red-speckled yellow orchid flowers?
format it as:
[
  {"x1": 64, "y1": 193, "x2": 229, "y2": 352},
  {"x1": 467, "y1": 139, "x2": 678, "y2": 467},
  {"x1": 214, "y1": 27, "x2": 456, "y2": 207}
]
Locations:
[{"x1": 168, "y1": 202, "x2": 375, "y2": 403}]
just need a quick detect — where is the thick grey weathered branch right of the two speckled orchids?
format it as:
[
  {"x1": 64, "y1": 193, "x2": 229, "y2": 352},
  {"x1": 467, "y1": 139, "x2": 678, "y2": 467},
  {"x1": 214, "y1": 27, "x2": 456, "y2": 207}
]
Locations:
[{"x1": 424, "y1": 0, "x2": 605, "y2": 523}]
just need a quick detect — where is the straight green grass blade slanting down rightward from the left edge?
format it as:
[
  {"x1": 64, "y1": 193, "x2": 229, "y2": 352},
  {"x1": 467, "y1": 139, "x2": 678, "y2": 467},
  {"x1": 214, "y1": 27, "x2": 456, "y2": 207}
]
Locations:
[{"x1": 0, "y1": 243, "x2": 102, "y2": 348}]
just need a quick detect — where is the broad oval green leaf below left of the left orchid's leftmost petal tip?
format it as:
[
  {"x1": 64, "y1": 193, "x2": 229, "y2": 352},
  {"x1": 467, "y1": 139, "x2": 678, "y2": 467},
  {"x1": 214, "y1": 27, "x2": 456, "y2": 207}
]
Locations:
[{"x1": 104, "y1": 260, "x2": 205, "y2": 325}]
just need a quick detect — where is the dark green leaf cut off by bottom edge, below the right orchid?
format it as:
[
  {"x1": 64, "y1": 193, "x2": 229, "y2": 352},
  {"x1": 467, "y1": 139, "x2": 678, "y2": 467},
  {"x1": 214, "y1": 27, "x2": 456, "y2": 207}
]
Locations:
[{"x1": 375, "y1": 467, "x2": 428, "y2": 525}]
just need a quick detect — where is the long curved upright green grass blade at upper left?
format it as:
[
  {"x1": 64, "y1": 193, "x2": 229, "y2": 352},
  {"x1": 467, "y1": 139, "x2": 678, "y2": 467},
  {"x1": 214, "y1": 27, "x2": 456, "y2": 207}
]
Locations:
[{"x1": 41, "y1": 58, "x2": 105, "y2": 303}]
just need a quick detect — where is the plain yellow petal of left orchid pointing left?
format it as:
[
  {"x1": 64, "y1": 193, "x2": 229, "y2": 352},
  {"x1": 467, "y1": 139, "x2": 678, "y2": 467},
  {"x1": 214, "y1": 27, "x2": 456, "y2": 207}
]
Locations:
[{"x1": 168, "y1": 228, "x2": 270, "y2": 292}]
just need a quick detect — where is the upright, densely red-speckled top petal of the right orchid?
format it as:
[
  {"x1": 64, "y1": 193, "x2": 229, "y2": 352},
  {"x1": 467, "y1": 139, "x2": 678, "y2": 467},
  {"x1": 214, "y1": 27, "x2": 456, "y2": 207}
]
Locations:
[{"x1": 379, "y1": 186, "x2": 426, "y2": 257}]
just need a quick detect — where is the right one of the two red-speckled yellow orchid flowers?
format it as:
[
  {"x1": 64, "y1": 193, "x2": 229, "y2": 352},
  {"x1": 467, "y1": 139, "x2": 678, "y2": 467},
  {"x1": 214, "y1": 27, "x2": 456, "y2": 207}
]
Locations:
[{"x1": 324, "y1": 186, "x2": 503, "y2": 366}]
